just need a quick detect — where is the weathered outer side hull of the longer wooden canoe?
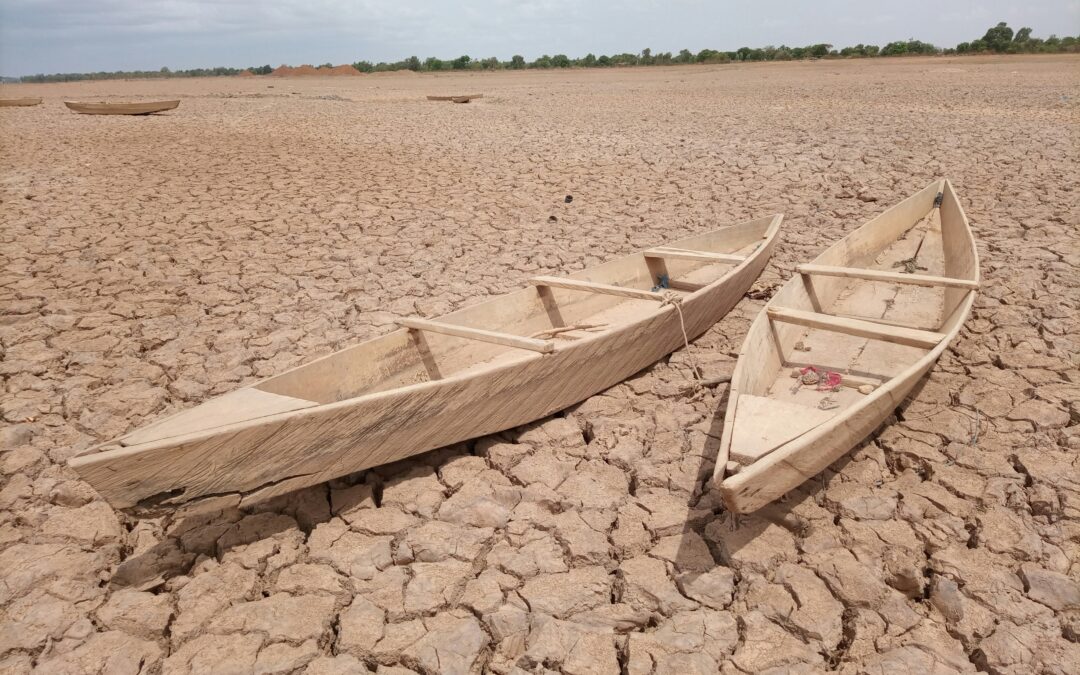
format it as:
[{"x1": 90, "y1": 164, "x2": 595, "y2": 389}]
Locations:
[{"x1": 71, "y1": 216, "x2": 780, "y2": 514}]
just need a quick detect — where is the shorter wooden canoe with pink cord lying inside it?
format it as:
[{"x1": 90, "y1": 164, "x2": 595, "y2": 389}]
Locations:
[{"x1": 714, "y1": 180, "x2": 978, "y2": 513}]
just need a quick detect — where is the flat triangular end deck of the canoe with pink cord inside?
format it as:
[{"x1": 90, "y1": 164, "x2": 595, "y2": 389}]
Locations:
[{"x1": 730, "y1": 394, "x2": 836, "y2": 465}]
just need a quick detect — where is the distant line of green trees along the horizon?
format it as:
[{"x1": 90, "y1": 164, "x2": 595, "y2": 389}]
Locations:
[{"x1": 21, "y1": 22, "x2": 1080, "y2": 82}]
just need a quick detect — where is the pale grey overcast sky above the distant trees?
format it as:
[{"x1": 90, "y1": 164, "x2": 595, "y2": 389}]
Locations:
[{"x1": 0, "y1": 0, "x2": 1080, "y2": 76}]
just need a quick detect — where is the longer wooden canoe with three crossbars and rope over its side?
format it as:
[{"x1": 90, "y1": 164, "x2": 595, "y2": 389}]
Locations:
[{"x1": 70, "y1": 215, "x2": 782, "y2": 514}]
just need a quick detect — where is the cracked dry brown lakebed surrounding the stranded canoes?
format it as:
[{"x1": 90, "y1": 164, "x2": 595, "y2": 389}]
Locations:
[{"x1": 0, "y1": 57, "x2": 1080, "y2": 675}]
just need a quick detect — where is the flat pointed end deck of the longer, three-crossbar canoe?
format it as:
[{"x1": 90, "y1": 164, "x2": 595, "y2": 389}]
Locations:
[{"x1": 120, "y1": 387, "x2": 319, "y2": 446}]
